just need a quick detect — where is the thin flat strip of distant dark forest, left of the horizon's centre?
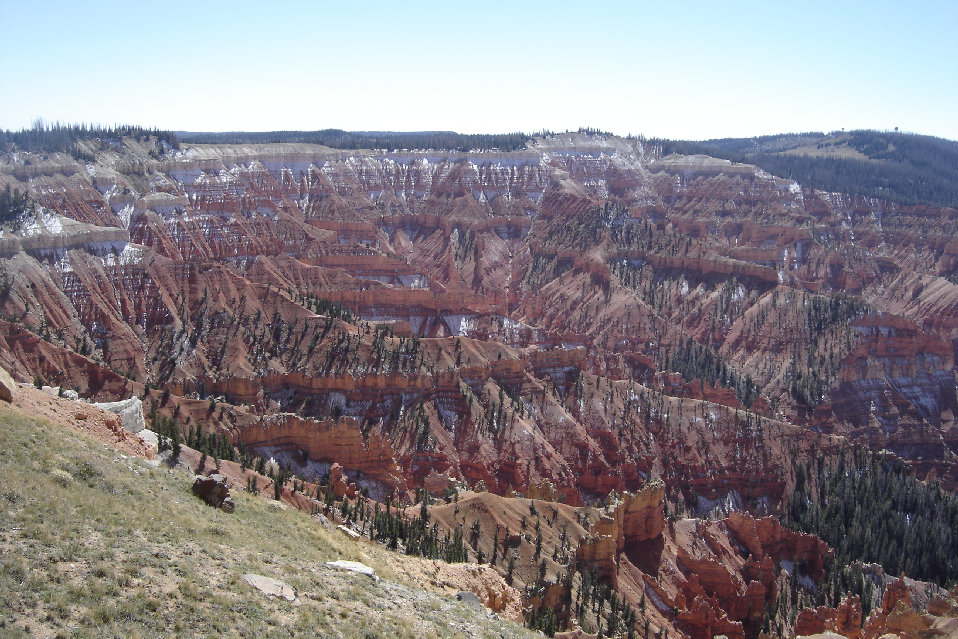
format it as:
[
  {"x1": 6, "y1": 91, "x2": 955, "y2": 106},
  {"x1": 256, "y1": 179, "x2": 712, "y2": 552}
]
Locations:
[{"x1": 176, "y1": 129, "x2": 532, "y2": 151}]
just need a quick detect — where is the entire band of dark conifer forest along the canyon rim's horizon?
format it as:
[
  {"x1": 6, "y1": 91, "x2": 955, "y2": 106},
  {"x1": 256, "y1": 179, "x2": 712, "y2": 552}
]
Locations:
[{"x1": 9, "y1": 121, "x2": 958, "y2": 208}]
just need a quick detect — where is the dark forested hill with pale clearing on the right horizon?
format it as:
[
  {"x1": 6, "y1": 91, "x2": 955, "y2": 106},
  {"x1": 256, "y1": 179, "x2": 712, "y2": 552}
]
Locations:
[{"x1": 650, "y1": 131, "x2": 958, "y2": 208}]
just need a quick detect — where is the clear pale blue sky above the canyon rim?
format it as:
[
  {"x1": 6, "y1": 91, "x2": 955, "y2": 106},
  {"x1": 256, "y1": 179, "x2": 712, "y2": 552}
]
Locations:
[{"x1": 0, "y1": 0, "x2": 958, "y2": 140}]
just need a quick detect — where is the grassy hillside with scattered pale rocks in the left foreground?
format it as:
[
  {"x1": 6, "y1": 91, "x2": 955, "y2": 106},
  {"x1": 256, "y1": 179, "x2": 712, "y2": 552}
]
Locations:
[{"x1": 0, "y1": 406, "x2": 533, "y2": 639}]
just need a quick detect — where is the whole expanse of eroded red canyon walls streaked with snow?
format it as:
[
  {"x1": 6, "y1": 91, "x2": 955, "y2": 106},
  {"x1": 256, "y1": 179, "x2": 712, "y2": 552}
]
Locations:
[{"x1": 0, "y1": 134, "x2": 958, "y2": 637}]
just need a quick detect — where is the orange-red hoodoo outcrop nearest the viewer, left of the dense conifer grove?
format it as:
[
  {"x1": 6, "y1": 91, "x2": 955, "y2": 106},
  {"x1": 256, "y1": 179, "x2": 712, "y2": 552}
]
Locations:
[{"x1": 510, "y1": 481, "x2": 832, "y2": 638}]
